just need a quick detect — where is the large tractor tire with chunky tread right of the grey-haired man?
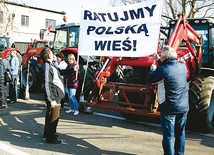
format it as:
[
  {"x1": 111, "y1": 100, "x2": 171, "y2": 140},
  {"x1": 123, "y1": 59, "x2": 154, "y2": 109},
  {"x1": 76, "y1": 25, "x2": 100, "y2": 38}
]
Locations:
[{"x1": 187, "y1": 76, "x2": 214, "y2": 133}]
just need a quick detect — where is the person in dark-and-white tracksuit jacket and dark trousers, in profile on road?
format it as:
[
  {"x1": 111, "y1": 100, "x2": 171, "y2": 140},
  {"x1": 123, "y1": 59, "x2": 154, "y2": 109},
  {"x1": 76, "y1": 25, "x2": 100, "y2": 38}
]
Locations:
[{"x1": 40, "y1": 47, "x2": 65, "y2": 144}]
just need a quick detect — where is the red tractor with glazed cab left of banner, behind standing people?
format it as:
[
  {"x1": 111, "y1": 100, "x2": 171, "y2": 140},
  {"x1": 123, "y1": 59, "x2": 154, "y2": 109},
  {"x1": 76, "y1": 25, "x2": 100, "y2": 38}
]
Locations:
[{"x1": 21, "y1": 23, "x2": 100, "y2": 101}]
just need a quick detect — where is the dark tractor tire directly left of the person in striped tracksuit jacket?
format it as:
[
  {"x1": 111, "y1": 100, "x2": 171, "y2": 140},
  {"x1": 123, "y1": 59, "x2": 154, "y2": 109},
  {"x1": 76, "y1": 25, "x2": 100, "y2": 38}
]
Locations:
[{"x1": 21, "y1": 65, "x2": 42, "y2": 93}]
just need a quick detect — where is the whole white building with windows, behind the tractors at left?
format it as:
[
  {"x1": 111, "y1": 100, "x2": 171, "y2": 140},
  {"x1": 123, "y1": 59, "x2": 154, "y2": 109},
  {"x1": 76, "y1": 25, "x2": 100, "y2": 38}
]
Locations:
[{"x1": 0, "y1": 1, "x2": 66, "y2": 52}]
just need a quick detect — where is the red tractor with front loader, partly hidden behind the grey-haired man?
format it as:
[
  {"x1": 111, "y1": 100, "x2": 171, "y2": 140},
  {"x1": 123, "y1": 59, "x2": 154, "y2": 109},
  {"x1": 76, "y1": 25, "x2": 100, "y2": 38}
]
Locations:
[{"x1": 80, "y1": 14, "x2": 214, "y2": 132}]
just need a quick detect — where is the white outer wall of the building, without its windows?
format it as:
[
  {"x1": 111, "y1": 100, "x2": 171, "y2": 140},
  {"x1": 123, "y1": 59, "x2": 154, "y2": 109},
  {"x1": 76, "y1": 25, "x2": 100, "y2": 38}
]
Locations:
[{"x1": 1, "y1": 2, "x2": 65, "y2": 52}]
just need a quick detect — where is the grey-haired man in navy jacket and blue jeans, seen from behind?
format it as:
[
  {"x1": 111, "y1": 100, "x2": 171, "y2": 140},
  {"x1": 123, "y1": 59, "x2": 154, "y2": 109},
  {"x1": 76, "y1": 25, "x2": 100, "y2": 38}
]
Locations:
[{"x1": 147, "y1": 46, "x2": 189, "y2": 155}]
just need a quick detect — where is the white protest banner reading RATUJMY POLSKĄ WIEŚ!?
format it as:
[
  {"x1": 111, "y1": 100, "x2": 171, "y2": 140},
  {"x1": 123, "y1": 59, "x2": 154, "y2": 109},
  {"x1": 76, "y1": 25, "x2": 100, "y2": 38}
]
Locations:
[{"x1": 78, "y1": 0, "x2": 162, "y2": 57}]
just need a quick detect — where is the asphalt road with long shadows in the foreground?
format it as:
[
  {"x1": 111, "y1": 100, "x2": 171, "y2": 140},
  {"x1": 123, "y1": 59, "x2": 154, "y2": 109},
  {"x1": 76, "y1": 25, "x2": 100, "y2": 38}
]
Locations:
[{"x1": 0, "y1": 94, "x2": 214, "y2": 155}]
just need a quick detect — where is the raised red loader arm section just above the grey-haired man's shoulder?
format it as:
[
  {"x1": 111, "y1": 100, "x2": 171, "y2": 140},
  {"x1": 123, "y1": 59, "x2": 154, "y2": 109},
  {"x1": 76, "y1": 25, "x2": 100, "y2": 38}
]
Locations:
[{"x1": 167, "y1": 14, "x2": 202, "y2": 78}]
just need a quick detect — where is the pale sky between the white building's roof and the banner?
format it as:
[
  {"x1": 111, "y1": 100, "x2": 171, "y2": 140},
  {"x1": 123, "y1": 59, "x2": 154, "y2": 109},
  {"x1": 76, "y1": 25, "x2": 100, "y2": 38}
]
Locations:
[{"x1": 10, "y1": 0, "x2": 111, "y2": 22}]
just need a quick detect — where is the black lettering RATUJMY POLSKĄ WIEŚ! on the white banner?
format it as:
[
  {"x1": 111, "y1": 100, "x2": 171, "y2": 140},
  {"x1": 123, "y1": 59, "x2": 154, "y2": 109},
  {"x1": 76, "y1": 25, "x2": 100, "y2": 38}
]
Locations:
[{"x1": 83, "y1": 4, "x2": 157, "y2": 52}]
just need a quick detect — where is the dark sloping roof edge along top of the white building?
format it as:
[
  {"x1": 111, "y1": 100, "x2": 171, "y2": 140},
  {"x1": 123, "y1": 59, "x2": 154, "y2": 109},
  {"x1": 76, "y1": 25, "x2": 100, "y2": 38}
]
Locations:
[{"x1": 4, "y1": 1, "x2": 66, "y2": 15}]
